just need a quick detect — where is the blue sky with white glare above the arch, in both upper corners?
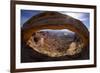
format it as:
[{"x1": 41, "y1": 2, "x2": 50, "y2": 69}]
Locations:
[{"x1": 21, "y1": 10, "x2": 90, "y2": 29}]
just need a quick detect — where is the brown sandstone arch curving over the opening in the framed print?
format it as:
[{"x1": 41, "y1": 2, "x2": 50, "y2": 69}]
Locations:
[{"x1": 21, "y1": 11, "x2": 89, "y2": 46}]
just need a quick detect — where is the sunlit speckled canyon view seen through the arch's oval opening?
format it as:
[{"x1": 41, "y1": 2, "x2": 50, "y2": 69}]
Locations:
[{"x1": 27, "y1": 29, "x2": 83, "y2": 57}]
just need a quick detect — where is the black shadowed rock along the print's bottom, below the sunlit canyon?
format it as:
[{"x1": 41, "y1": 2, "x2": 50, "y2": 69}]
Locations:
[{"x1": 21, "y1": 43, "x2": 89, "y2": 63}]
